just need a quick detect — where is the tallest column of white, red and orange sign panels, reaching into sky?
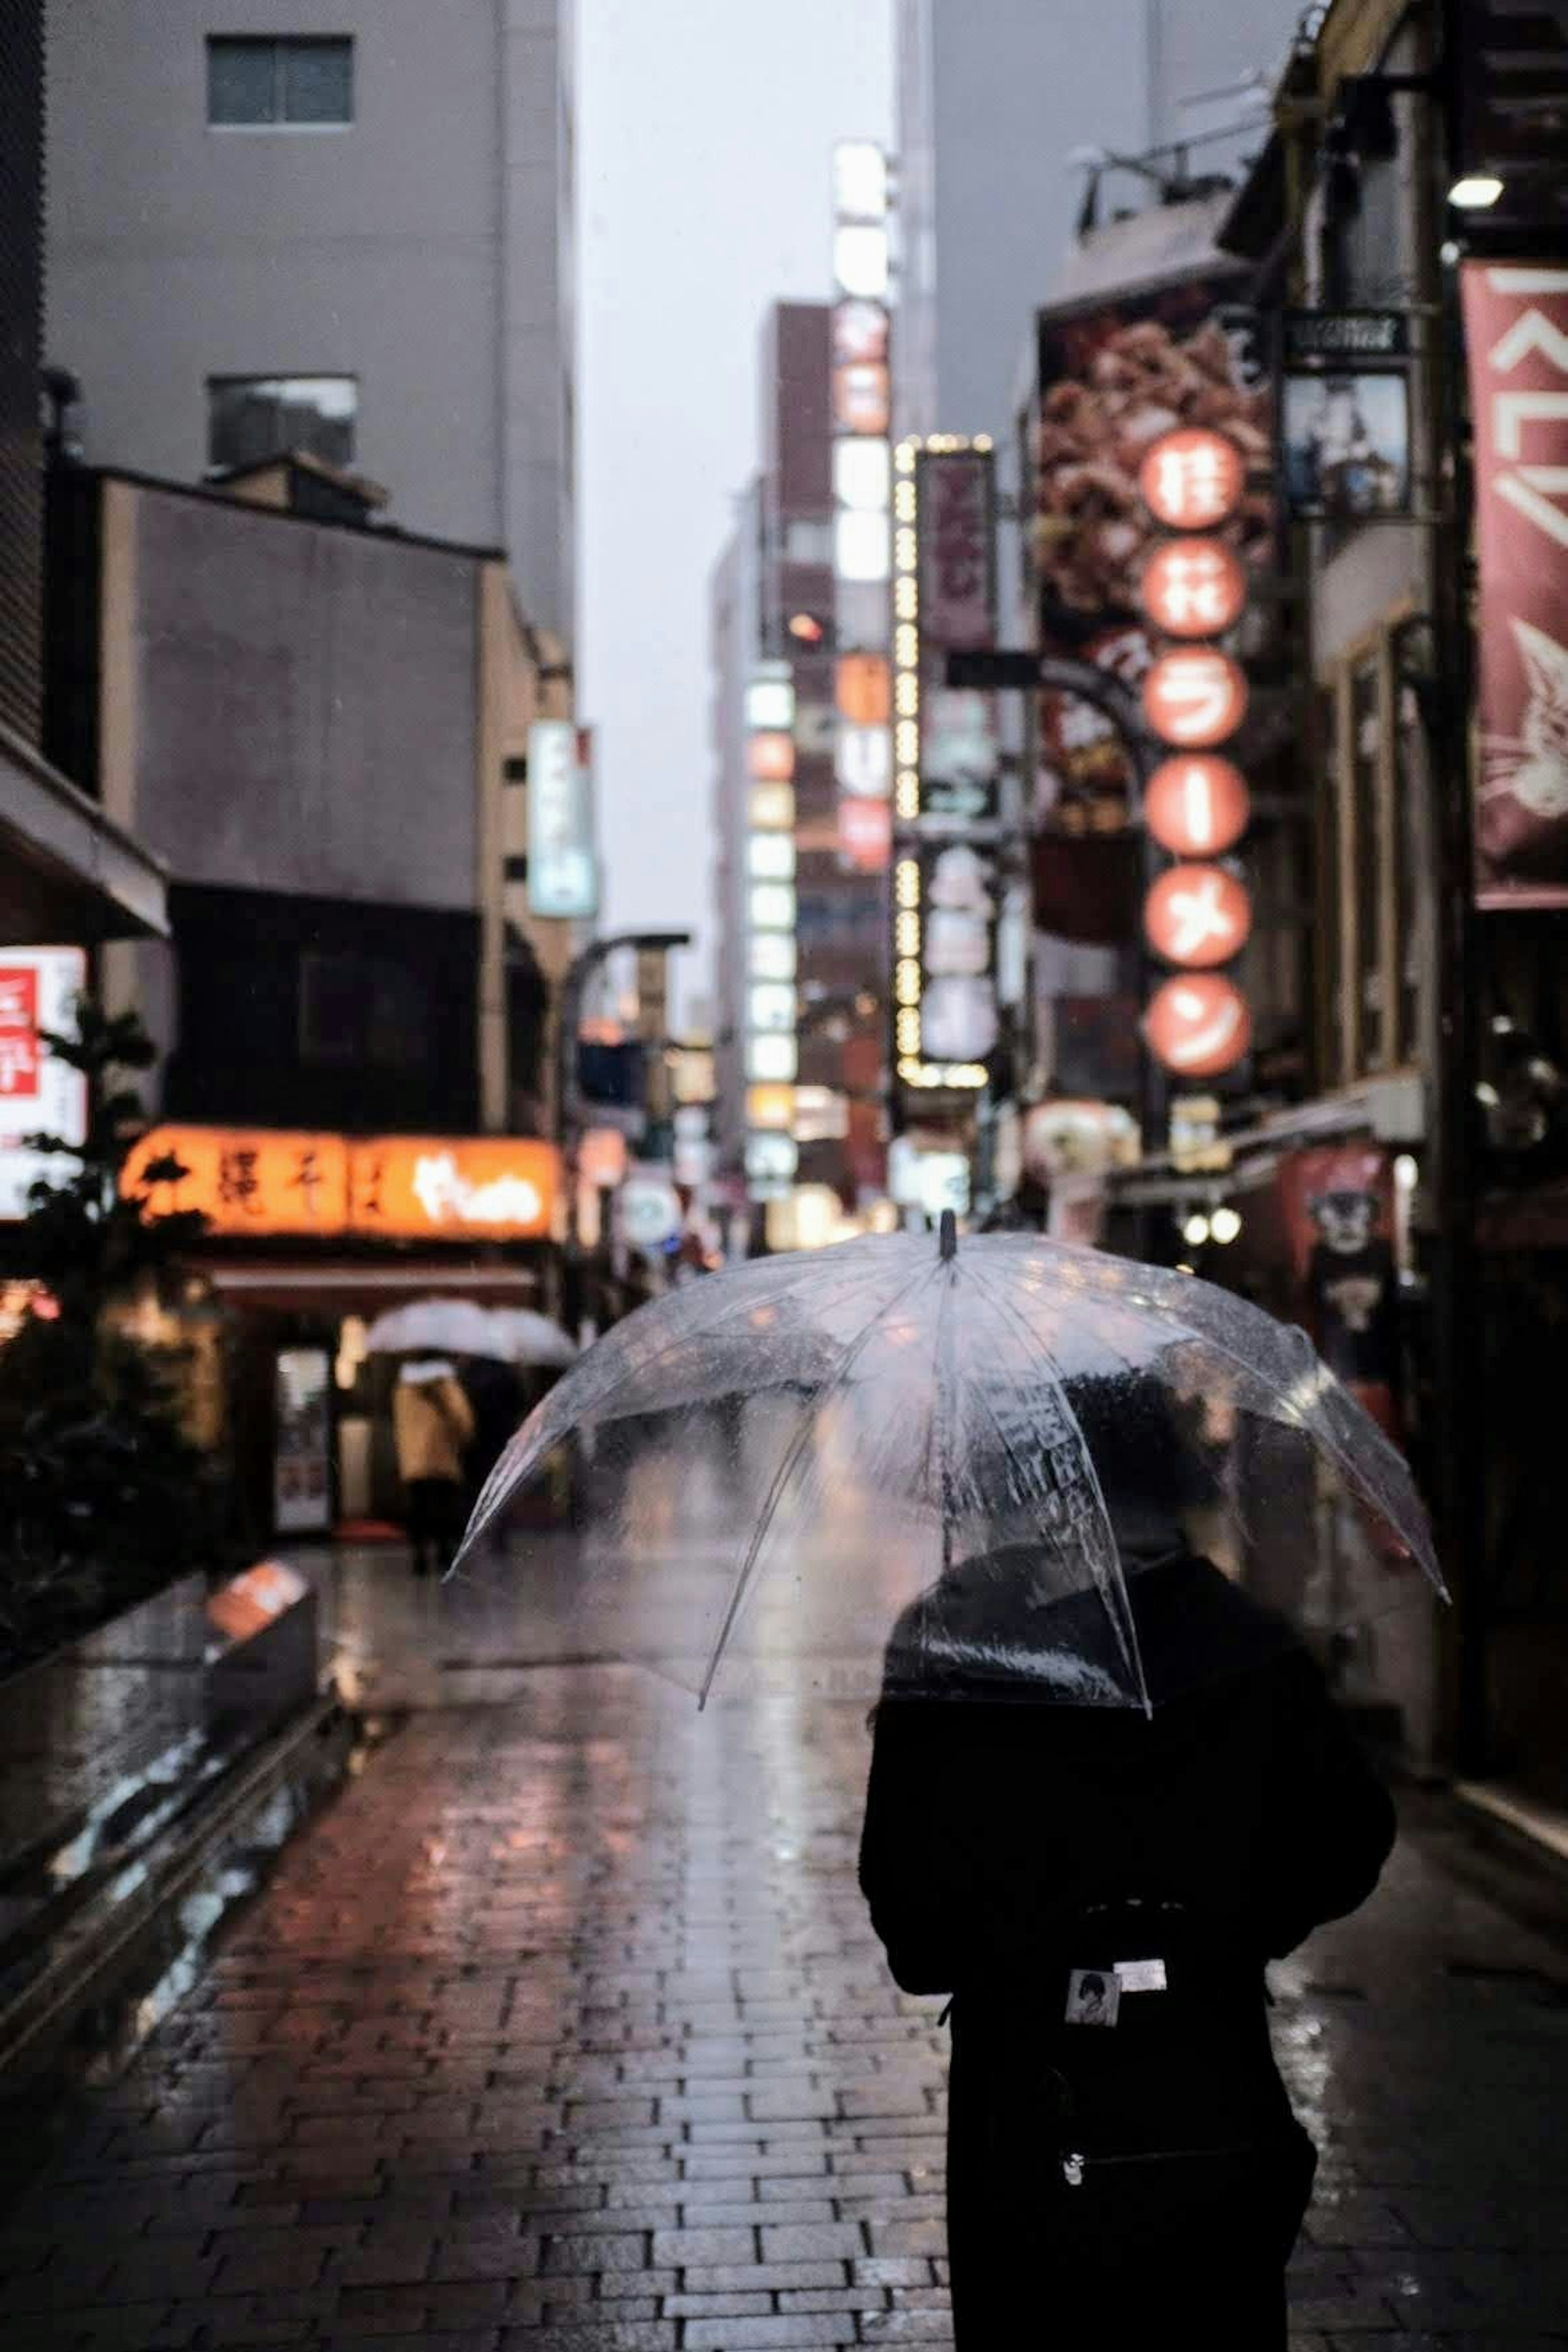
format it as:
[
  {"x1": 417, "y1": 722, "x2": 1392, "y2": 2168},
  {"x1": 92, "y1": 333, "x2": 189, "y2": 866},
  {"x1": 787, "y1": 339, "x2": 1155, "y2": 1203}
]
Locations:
[{"x1": 832, "y1": 141, "x2": 893, "y2": 875}]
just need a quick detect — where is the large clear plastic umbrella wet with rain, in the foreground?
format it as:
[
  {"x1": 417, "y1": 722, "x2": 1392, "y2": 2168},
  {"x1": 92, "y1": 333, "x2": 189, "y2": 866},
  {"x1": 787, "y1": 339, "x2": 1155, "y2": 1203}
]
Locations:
[{"x1": 459, "y1": 1223, "x2": 1443, "y2": 1708}]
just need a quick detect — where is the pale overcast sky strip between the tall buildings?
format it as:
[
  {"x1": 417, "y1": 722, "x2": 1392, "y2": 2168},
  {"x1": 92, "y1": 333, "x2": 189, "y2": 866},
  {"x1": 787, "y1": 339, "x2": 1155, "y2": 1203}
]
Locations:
[{"x1": 576, "y1": 0, "x2": 893, "y2": 1016}]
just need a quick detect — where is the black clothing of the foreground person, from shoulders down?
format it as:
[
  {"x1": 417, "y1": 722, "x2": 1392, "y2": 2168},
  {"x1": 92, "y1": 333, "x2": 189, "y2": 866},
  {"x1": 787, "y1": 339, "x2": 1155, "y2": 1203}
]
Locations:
[{"x1": 860, "y1": 1552, "x2": 1394, "y2": 2352}]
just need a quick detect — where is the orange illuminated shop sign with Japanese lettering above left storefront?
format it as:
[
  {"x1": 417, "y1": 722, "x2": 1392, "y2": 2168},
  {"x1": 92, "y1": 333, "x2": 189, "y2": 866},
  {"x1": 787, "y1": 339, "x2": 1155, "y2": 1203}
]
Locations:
[{"x1": 125, "y1": 1127, "x2": 559, "y2": 1242}]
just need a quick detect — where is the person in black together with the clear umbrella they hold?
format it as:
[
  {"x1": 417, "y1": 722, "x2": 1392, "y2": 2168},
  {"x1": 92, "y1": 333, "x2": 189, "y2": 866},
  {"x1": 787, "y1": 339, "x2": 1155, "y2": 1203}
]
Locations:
[{"x1": 446, "y1": 1216, "x2": 1446, "y2": 2352}]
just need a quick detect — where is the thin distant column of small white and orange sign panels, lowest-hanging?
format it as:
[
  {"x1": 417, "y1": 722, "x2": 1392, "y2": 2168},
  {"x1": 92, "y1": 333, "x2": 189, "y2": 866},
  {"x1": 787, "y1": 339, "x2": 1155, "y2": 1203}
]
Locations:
[{"x1": 745, "y1": 661, "x2": 799, "y2": 1200}]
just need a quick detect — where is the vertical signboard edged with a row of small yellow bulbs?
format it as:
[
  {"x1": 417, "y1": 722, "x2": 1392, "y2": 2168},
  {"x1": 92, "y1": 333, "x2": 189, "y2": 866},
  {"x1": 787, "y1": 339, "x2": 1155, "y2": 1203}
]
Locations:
[{"x1": 893, "y1": 435, "x2": 1002, "y2": 1120}]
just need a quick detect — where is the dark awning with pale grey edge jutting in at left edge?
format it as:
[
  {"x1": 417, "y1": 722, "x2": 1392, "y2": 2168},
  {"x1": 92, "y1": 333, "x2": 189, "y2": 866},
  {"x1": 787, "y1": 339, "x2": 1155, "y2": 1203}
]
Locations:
[{"x1": 0, "y1": 727, "x2": 169, "y2": 948}]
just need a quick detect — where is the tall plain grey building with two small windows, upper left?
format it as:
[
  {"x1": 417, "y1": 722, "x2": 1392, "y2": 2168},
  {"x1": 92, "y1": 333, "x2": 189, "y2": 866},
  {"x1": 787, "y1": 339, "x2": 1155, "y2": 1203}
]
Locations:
[{"x1": 47, "y1": 0, "x2": 574, "y2": 635}]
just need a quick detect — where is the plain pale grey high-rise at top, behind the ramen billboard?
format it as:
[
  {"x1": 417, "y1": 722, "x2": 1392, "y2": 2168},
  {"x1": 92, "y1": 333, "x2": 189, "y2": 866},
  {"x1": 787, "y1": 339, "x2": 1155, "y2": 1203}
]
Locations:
[{"x1": 893, "y1": 0, "x2": 1300, "y2": 449}]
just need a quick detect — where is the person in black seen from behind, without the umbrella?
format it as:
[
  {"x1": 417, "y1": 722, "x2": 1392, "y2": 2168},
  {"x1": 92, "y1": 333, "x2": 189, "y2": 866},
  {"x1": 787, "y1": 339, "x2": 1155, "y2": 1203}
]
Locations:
[{"x1": 860, "y1": 1376, "x2": 1394, "y2": 2352}]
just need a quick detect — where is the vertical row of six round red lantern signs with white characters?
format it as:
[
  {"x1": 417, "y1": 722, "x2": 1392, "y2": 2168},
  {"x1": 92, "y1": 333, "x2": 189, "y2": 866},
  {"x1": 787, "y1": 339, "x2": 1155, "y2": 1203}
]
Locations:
[{"x1": 1140, "y1": 426, "x2": 1253, "y2": 1080}]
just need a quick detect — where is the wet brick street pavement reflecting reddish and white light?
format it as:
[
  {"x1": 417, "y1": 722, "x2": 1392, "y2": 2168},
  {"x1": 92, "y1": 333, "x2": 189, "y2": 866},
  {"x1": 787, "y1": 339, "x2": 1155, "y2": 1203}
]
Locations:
[{"x1": 0, "y1": 1543, "x2": 1568, "y2": 2352}]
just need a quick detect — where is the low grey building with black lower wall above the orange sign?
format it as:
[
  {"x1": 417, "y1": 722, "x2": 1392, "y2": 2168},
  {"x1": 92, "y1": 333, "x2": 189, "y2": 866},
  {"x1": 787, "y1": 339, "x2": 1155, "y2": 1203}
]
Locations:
[{"x1": 45, "y1": 466, "x2": 574, "y2": 1134}]
